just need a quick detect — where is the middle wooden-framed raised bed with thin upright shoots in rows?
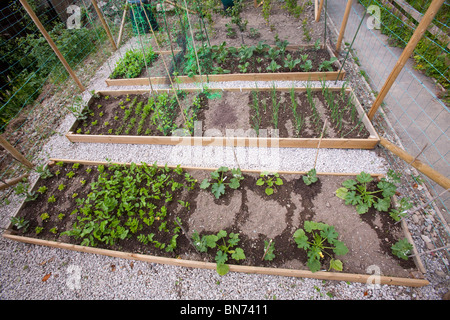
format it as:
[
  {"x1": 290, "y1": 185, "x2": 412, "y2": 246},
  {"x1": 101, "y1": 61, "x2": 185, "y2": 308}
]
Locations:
[{"x1": 66, "y1": 88, "x2": 379, "y2": 149}]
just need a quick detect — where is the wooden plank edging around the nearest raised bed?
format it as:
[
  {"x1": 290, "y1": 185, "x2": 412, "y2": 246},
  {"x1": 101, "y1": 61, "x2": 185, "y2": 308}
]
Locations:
[{"x1": 3, "y1": 158, "x2": 429, "y2": 287}]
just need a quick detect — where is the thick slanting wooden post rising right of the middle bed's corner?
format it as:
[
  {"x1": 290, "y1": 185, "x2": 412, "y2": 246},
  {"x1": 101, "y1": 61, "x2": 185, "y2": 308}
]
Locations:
[{"x1": 367, "y1": 0, "x2": 444, "y2": 120}]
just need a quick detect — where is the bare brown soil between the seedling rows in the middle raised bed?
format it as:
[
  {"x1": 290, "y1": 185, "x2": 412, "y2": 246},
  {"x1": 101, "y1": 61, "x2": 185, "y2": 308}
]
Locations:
[{"x1": 71, "y1": 91, "x2": 370, "y2": 139}]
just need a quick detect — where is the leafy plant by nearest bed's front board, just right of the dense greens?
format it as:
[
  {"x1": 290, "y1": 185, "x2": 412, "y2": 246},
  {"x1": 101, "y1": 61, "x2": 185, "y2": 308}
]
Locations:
[{"x1": 192, "y1": 230, "x2": 245, "y2": 276}]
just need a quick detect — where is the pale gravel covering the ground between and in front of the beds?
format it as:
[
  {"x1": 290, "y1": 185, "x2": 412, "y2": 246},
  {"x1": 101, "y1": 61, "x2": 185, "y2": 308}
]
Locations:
[{"x1": 0, "y1": 26, "x2": 449, "y2": 300}]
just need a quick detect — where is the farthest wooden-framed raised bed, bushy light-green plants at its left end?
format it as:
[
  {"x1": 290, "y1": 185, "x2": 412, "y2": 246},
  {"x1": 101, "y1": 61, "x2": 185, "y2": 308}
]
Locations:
[{"x1": 106, "y1": 40, "x2": 345, "y2": 86}]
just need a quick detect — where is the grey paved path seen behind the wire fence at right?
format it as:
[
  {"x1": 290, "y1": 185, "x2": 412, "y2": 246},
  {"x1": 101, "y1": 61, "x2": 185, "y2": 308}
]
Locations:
[{"x1": 327, "y1": 0, "x2": 450, "y2": 209}]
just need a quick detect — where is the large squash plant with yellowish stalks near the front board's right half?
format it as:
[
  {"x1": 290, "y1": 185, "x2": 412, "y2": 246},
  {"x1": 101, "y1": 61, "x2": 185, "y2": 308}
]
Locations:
[{"x1": 293, "y1": 221, "x2": 348, "y2": 272}]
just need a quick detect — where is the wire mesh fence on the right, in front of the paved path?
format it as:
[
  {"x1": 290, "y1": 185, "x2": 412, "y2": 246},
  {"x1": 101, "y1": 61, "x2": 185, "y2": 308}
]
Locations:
[{"x1": 328, "y1": 0, "x2": 450, "y2": 268}]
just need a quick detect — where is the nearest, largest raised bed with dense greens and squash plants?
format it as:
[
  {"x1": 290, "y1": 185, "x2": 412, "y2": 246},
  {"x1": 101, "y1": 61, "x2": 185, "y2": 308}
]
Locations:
[{"x1": 3, "y1": 159, "x2": 428, "y2": 286}]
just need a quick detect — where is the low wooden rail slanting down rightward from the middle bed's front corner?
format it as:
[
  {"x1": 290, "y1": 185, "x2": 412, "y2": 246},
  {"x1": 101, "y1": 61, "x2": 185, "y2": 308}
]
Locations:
[{"x1": 380, "y1": 137, "x2": 450, "y2": 189}]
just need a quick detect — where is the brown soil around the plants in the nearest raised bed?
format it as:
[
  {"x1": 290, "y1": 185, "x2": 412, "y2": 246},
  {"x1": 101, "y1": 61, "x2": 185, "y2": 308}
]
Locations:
[{"x1": 12, "y1": 163, "x2": 415, "y2": 275}]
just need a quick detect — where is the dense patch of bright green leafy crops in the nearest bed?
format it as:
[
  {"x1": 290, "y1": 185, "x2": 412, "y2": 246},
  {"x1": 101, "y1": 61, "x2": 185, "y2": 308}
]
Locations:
[{"x1": 62, "y1": 163, "x2": 196, "y2": 252}]
